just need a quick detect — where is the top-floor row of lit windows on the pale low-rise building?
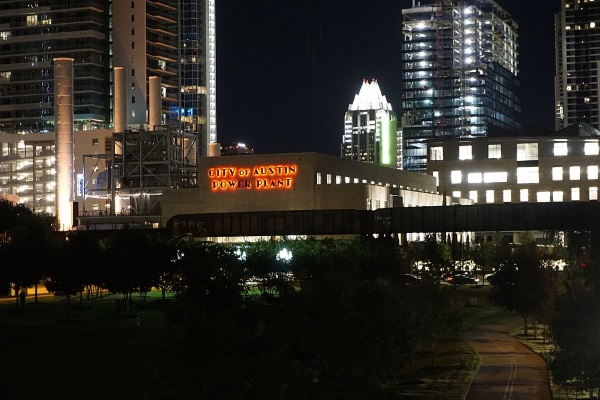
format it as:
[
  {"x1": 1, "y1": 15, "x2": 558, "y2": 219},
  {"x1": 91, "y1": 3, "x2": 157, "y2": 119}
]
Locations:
[{"x1": 429, "y1": 140, "x2": 600, "y2": 161}]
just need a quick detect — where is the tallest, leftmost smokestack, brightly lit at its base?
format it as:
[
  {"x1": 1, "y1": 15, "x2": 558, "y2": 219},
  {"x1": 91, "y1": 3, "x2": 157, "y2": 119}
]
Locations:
[{"x1": 54, "y1": 58, "x2": 75, "y2": 231}]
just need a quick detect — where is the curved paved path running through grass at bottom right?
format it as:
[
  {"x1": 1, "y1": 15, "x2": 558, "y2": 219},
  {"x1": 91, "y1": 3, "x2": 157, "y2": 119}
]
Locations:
[{"x1": 465, "y1": 317, "x2": 552, "y2": 400}]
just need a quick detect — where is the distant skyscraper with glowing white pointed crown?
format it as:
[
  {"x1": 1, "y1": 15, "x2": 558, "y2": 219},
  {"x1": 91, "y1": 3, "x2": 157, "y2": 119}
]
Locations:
[{"x1": 341, "y1": 80, "x2": 401, "y2": 169}]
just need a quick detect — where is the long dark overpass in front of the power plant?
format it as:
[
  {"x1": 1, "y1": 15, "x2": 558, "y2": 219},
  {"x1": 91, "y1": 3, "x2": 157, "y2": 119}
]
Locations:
[{"x1": 166, "y1": 201, "x2": 600, "y2": 237}]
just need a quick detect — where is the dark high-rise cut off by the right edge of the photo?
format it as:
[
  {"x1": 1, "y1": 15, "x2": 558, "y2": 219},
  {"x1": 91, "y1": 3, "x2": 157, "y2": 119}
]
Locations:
[{"x1": 555, "y1": 0, "x2": 600, "y2": 130}]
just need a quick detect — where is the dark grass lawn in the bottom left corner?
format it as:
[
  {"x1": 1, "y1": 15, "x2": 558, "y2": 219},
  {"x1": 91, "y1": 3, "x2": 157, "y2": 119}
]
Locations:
[{"x1": 0, "y1": 295, "x2": 169, "y2": 400}]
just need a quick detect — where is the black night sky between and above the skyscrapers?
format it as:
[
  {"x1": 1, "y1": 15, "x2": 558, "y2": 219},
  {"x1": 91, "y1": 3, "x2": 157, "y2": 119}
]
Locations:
[{"x1": 216, "y1": 0, "x2": 560, "y2": 156}]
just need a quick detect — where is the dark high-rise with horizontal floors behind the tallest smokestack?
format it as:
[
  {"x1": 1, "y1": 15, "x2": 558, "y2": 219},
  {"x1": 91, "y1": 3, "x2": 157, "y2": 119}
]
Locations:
[{"x1": 0, "y1": 0, "x2": 110, "y2": 134}]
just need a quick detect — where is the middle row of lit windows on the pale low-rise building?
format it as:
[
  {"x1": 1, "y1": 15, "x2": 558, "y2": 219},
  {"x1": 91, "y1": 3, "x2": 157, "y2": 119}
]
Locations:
[{"x1": 448, "y1": 165, "x2": 599, "y2": 185}]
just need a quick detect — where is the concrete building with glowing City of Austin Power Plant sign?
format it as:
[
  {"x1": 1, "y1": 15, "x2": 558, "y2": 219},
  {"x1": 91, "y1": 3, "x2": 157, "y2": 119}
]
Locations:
[{"x1": 161, "y1": 153, "x2": 464, "y2": 226}]
